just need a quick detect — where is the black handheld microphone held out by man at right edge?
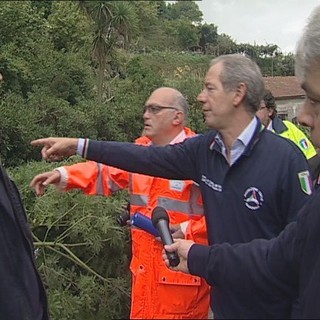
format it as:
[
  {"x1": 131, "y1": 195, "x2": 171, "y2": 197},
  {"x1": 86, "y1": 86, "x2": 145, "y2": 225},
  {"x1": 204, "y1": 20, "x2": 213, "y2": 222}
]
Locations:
[{"x1": 151, "y1": 207, "x2": 180, "y2": 267}]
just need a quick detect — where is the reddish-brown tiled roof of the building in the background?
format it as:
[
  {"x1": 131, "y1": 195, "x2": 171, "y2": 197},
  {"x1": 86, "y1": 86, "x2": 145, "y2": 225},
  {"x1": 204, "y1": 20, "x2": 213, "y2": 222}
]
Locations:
[{"x1": 263, "y1": 76, "x2": 305, "y2": 100}]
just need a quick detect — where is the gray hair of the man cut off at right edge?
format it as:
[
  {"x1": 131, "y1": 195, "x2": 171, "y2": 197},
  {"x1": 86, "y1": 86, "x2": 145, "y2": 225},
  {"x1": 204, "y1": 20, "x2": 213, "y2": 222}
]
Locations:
[{"x1": 295, "y1": 6, "x2": 320, "y2": 81}]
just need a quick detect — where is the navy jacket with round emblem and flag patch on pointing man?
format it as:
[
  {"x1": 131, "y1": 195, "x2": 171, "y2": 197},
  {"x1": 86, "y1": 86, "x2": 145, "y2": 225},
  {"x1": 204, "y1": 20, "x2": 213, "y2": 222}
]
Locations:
[{"x1": 87, "y1": 119, "x2": 310, "y2": 318}]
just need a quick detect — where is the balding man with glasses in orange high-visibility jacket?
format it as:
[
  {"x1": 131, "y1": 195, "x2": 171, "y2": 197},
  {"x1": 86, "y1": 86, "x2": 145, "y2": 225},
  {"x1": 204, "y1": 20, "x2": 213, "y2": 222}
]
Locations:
[{"x1": 31, "y1": 88, "x2": 209, "y2": 319}]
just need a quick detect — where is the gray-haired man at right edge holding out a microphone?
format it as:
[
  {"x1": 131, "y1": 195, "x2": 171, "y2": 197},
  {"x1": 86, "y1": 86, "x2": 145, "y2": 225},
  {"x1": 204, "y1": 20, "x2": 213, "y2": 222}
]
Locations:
[{"x1": 160, "y1": 6, "x2": 320, "y2": 319}]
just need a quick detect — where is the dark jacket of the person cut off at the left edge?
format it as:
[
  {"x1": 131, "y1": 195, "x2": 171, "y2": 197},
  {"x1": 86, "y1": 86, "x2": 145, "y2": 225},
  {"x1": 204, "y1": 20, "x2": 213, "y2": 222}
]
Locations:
[{"x1": 0, "y1": 166, "x2": 48, "y2": 320}]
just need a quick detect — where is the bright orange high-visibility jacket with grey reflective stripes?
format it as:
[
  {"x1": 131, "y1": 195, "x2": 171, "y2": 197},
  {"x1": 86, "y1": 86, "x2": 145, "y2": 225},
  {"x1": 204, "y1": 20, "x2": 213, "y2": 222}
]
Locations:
[{"x1": 58, "y1": 128, "x2": 209, "y2": 319}]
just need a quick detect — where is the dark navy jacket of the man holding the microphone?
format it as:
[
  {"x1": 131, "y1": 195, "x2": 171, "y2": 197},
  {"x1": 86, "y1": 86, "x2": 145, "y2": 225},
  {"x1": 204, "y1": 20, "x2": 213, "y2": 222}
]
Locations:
[{"x1": 188, "y1": 186, "x2": 320, "y2": 319}]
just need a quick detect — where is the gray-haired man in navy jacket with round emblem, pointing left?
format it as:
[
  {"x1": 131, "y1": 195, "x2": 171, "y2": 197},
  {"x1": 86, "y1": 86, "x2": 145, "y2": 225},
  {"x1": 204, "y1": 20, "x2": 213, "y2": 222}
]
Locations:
[{"x1": 32, "y1": 55, "x2": 312, "y2": 318}]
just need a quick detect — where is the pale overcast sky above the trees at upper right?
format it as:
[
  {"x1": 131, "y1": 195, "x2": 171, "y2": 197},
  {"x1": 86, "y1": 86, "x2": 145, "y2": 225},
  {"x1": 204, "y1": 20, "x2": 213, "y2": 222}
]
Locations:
[{"x1": 196, "y1": 0, "x2": 320, "y2": 53}]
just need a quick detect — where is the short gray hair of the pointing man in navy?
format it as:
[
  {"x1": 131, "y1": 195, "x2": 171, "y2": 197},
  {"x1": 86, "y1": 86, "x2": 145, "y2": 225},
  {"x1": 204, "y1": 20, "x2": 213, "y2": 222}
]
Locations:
[{"x1": 210, "y1": 54, "x2": 264, "y2": 113}]
